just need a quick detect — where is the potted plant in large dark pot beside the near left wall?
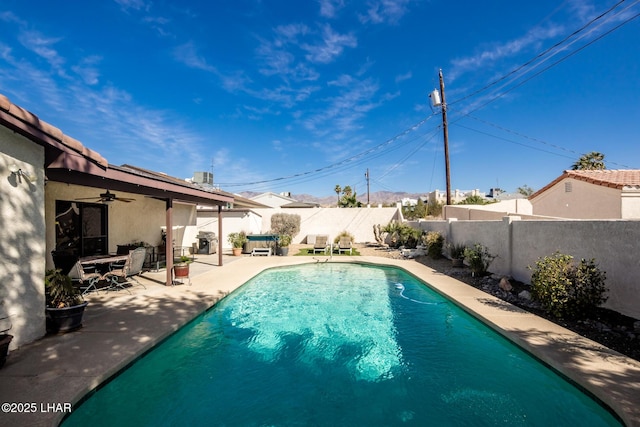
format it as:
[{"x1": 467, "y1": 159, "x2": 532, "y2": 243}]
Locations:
[{"x1": 44, "y1": 269, "x2": 88, "y2": 334}]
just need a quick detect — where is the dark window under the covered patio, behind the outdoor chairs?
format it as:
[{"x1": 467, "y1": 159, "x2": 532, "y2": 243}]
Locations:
[{"x1": 56, "y1": 200, "x2": 108, "y2": 258}]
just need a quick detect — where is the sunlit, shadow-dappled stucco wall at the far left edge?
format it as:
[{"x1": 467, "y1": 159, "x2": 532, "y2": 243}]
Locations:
[{"x1": 0, "y1": 127, "x2": 45, "y2": 348}]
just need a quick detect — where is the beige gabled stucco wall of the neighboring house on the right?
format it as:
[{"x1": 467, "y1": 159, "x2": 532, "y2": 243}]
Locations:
[{"x1": 531, "y1": 178, "x2": 622, "y2": 219}]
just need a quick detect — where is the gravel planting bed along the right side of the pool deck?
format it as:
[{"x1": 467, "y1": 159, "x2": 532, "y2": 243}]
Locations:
[{"x1": 332, "y1": 244, "x2": 640, "y2": 361}]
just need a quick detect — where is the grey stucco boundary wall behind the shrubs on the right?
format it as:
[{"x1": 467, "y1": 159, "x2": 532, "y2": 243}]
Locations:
[{"x1": 420, "y1": 217, "x2": 640, "y2": 319}]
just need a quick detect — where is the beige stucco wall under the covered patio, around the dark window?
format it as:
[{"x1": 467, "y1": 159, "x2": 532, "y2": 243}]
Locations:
[{"x1": 45, "y1": 182, "x2": 196, "y2": 268}]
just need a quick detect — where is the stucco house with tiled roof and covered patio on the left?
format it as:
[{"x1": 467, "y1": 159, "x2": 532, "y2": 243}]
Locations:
[{"x1": 0, "y1": 95, "x2": 234, "y2": 348}]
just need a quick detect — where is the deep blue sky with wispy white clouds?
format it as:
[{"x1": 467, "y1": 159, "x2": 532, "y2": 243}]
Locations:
[{"x1": 0, "y1": 0, "x2": 640, "y2": 196}]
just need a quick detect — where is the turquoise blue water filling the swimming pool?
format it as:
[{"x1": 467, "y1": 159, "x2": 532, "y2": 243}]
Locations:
[{"x1": 63, "y1": 263, "x2": 620, "y2": 427}]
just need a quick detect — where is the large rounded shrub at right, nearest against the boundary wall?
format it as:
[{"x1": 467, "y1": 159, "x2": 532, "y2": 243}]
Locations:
[{"x1": 529, "y1": 252, "x2": 607, "y2": 318}]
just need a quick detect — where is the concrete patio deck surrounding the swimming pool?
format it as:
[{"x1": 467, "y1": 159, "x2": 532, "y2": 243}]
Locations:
[{"x1": 0, "y1": 255, "x2": 640, "y2": 426}]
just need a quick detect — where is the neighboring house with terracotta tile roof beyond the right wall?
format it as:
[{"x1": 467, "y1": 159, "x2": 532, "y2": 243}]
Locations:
[{"x1": 529, "y1": 169, "x2": 640, "y2": 219}]
